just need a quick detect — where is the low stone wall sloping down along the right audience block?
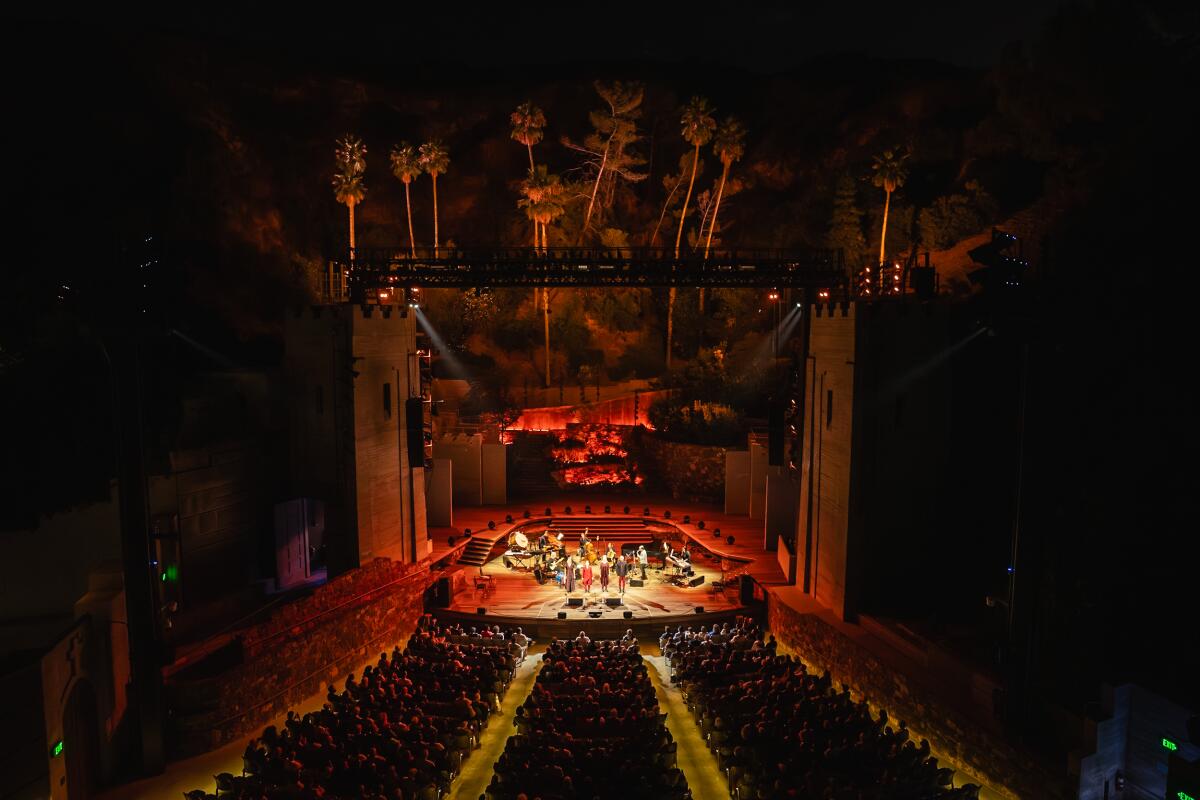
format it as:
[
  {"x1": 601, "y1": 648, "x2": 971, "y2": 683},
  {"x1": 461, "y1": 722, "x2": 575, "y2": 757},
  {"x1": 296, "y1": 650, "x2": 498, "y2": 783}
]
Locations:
[{"x1": 767, "y1": 593, "x2": 1054, "y2": 798}]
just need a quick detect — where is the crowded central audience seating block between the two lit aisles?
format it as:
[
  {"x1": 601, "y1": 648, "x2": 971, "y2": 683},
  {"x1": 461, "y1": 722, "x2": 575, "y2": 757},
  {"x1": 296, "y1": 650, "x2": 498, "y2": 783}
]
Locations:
[{"x1": 487, "y1": 633, "x2": 691, "y2": 800}]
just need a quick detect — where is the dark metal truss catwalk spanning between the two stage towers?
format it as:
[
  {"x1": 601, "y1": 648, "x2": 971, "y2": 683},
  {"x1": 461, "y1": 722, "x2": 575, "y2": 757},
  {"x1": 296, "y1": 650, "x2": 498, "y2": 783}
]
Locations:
[{"x1": 326, "y1": 247, "x2": 848, "y2": 302}]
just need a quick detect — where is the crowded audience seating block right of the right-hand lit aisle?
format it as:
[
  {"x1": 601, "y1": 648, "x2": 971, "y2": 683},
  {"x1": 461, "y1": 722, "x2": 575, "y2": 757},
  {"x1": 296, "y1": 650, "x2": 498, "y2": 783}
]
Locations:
[{"x1": 659, "y1": 619, "x2": 979, "y2": 800}]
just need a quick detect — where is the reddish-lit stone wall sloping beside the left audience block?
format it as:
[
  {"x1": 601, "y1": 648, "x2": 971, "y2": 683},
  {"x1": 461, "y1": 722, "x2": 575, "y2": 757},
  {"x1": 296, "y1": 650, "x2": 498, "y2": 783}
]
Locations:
[{"x1": 168, "y1": 559, "x2": 432, "y2": 757}]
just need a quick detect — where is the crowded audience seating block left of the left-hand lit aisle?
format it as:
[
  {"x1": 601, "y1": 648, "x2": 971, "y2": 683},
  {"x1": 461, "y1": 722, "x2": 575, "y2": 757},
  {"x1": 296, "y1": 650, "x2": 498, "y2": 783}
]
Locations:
[{"x1": 185, "y1": 615, "x2": 529, "y2": 800}]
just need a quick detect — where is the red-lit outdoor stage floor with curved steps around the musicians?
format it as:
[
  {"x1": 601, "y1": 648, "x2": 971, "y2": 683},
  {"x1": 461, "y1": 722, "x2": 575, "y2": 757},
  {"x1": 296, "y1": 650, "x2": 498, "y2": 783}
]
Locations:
[{"x1": 433, "y1": 497, "x2": 784, "y2": 638}]
